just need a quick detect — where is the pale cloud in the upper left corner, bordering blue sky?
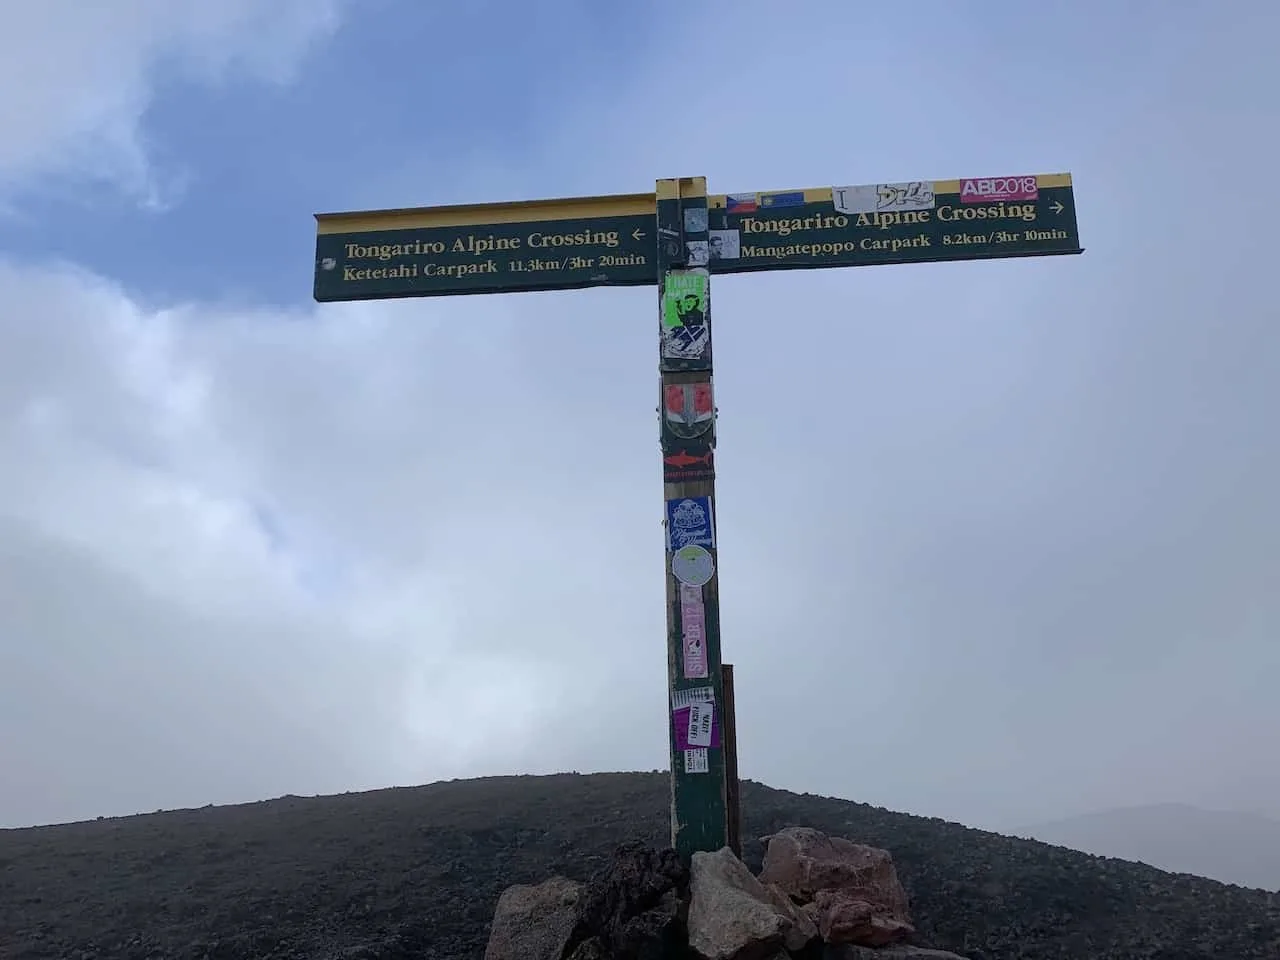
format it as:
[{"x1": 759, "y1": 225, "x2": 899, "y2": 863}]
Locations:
[{"x1": 0, "y1": 0, "x2": 338, "y2": 206}]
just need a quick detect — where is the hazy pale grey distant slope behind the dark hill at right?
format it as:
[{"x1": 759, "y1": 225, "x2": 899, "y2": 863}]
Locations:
[{"x1": 1018, "y1": 804, "x2": 1280, "y2": 891}]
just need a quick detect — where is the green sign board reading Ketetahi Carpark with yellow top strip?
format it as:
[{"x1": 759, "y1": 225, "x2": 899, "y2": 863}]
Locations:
[{"x1": 315, "y1": 193, "x2": 657, "y2": 301}]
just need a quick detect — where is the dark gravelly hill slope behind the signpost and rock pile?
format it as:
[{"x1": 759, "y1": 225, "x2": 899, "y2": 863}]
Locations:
[{"x1": 0, "y1": 773, "x2": 1280, "y2": 960}]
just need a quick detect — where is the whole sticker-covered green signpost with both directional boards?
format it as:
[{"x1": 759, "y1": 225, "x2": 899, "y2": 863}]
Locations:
[{"x1": 315, "y1": 168, "x2": 1083, "y2": 860}]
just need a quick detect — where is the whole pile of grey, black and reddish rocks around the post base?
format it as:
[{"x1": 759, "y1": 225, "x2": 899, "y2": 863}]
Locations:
[{"x1": 485, "y1": 827, "x2": 964, "y2": 960}]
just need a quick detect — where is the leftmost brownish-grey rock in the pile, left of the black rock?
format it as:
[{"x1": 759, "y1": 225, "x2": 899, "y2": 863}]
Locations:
[{"x1": 484, "y1": 877, "x2": 582, "y2": 960}]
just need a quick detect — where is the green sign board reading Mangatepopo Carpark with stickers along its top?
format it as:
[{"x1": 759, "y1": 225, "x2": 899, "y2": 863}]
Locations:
[{"x1": 709, "y1": 174, "x2": 1082, "y2": 274}]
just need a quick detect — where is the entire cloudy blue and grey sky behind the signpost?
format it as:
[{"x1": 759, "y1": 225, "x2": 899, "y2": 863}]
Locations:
[{"x1": 0, "y1": 0, "x2": 1280, "y2": 829}]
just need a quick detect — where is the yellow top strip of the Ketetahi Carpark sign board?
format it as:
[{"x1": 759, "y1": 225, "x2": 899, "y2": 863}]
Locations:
[{"x1": 315, "y1": 193, "x2": 658, "y2": 234}]
